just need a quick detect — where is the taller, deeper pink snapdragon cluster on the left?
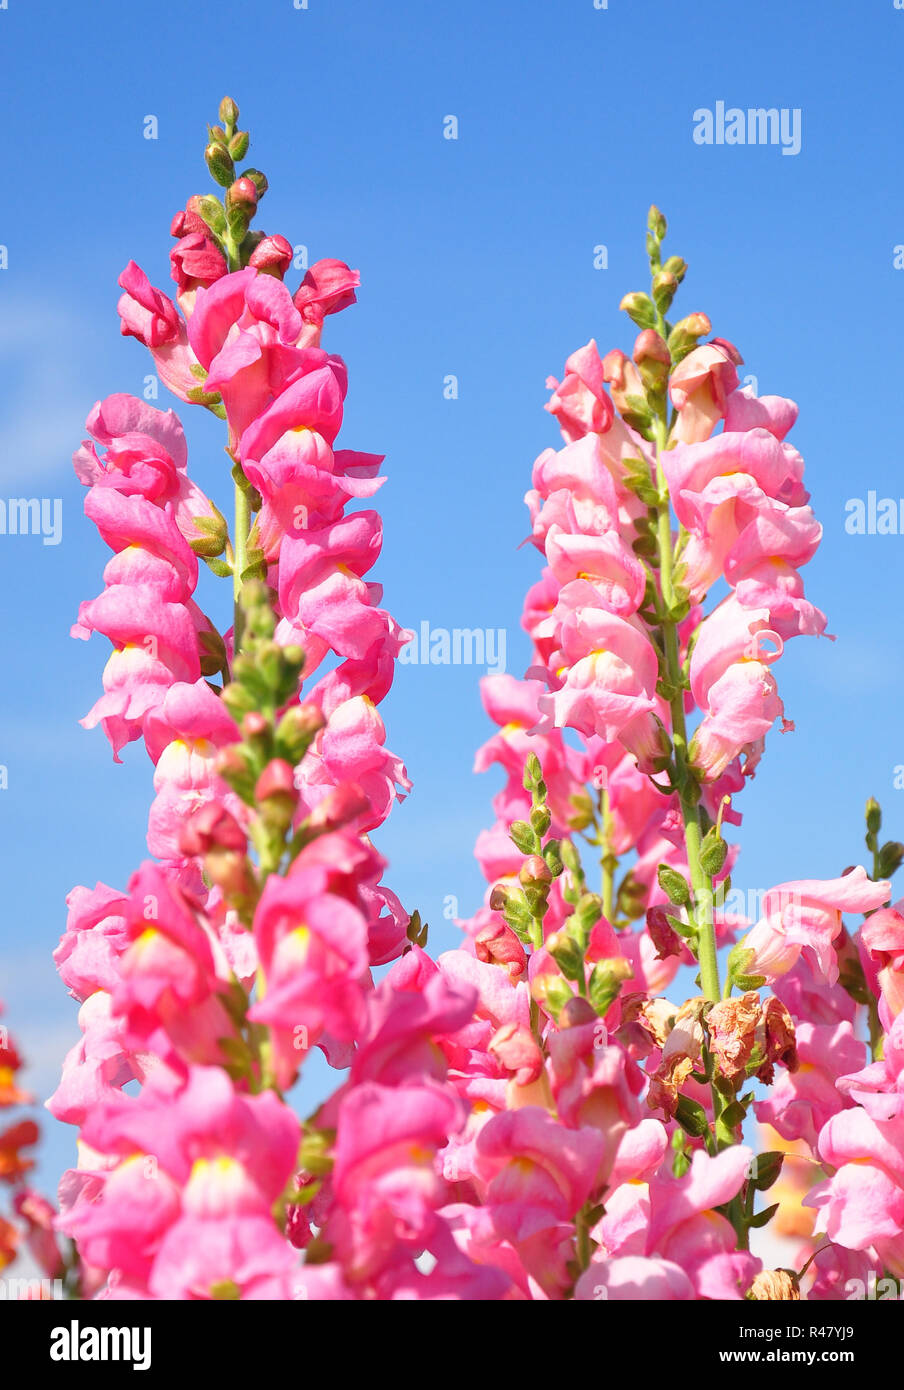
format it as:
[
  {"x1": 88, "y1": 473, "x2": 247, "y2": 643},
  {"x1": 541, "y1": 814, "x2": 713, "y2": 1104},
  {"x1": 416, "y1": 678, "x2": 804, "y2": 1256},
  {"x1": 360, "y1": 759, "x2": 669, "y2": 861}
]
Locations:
[{"x1": 49, "y1": 99, "x2": 420, "y2": 1298}]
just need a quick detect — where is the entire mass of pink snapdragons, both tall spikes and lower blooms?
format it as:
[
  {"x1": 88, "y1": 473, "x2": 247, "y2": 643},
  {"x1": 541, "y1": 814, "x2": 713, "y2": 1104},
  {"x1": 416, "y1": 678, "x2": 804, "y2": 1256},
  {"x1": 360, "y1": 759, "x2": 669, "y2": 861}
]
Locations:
[{"x1": 47, "y1": 99, "x2": 904, "y2": 1301}]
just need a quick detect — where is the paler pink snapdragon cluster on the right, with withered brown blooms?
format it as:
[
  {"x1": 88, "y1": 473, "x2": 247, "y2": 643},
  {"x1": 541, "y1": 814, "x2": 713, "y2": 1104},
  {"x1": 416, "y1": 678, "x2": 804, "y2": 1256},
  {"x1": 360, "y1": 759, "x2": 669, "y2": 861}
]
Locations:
[{"x1": 462, "y1": 209, "x2": 904, "y2": 1300}]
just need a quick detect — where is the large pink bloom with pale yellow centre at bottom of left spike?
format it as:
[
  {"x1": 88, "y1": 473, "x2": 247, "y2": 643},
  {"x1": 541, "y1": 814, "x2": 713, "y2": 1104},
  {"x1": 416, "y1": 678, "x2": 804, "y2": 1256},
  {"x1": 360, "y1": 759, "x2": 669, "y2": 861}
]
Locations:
[{"x1": 60, "y1": 1068, "x2": 299, "y2": 1298}]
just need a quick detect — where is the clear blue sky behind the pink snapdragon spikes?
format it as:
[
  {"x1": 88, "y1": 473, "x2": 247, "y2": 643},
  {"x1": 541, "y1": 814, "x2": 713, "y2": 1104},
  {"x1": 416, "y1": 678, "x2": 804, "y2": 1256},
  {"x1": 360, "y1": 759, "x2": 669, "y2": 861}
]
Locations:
[{"x1": 0, "y1": 0, "x2": 904, "y2": 1180}]
